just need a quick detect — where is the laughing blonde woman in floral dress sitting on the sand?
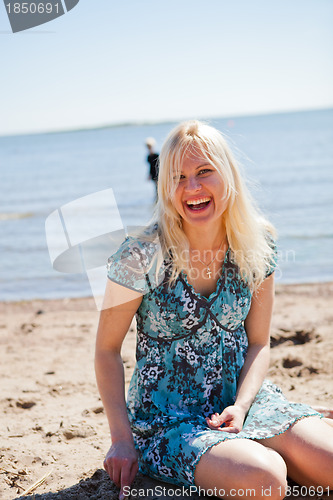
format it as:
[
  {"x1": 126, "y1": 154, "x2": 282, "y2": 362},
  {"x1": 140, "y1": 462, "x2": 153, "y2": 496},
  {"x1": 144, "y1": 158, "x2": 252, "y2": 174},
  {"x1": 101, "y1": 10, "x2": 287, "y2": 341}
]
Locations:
[{"x1": 96, "y1": 121, "x2": 333, "y2": 499}]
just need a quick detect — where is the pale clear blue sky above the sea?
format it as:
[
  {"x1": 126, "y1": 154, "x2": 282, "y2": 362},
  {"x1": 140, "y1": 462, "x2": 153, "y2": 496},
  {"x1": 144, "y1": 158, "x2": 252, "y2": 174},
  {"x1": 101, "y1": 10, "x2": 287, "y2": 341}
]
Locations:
[{"x1": 0, "y1": 0, "x2": 333, "y2": 135}]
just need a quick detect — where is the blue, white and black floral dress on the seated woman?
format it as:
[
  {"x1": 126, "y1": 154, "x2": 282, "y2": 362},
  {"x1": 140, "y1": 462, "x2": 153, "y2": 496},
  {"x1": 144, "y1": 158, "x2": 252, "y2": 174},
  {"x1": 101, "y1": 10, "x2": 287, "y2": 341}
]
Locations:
[{"x1": 108, "y1": 234, "x2": 320, "y2": 486}]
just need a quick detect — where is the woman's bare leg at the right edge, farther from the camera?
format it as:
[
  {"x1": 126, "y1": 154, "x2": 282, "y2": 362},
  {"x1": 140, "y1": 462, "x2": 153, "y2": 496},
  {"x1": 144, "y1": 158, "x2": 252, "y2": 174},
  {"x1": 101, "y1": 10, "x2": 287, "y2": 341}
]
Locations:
[{"x1": 259, "y1": 417, "x2": 333, "y2": 489}]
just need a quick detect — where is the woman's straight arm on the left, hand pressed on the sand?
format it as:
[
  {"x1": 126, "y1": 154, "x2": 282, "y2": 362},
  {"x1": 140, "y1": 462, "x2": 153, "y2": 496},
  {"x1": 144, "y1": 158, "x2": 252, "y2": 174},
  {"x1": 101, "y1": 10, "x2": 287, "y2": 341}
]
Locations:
[{"x1": 95, "y1": 282, "x2": 142, "y2": 498}]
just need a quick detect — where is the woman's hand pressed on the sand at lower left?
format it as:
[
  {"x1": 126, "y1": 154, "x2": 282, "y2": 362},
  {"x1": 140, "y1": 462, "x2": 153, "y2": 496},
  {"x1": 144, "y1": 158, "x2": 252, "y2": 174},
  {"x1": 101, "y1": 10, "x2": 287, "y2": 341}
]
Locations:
[{"x1": 104, "y1": 441, "x2": 139, "y2": 500}]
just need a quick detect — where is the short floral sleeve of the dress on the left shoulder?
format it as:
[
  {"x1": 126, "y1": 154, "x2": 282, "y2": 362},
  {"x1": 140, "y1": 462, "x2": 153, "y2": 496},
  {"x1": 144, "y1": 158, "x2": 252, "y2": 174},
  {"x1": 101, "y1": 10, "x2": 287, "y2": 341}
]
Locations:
[{"x1": 107, "y1": 237, "x2": 164, "y2": 294}]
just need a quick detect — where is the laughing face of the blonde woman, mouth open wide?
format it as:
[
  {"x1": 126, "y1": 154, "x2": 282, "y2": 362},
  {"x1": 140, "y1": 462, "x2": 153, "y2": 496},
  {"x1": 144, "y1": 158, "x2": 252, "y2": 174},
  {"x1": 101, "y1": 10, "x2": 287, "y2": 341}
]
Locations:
[{"x1": 173, "y1": 149, "x2": 227, "y2": 231}]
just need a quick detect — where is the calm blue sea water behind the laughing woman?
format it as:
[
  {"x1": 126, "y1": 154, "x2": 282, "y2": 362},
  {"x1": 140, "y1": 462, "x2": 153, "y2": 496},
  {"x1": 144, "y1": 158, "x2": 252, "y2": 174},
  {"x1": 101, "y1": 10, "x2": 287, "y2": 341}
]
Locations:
[{"x1": 0, "y1": 109, "x2": 333, "y2": 300}]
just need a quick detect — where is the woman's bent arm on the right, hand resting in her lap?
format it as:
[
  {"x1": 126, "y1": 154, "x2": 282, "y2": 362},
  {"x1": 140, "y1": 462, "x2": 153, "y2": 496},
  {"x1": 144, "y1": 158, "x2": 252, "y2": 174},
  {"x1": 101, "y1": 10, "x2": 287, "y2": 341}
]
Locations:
[{"x1": 207, "y1": 273, "x2": 274, "y2": 432}]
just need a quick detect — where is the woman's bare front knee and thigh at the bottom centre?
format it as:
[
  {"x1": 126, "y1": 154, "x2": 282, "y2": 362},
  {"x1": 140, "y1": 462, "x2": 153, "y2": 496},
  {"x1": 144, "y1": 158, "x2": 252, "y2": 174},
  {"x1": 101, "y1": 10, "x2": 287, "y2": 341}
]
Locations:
[{"x1": 195, "y1": 439, "x2": 287, "y2": 500}]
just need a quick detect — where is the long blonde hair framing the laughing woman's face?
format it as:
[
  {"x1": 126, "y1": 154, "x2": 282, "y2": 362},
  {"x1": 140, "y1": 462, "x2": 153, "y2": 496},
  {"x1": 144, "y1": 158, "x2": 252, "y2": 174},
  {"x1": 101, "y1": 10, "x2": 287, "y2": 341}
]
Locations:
[{"x1": 155, "y1": 120, "x2": 275, "y2": 290}]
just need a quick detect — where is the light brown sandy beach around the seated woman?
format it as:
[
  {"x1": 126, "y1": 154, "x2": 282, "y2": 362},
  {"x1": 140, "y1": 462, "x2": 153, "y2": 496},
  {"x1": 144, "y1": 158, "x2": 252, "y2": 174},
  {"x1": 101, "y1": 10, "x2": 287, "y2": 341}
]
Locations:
[{"x1": 0, "y1": 283, "x2": 333, "y2": 500}]
